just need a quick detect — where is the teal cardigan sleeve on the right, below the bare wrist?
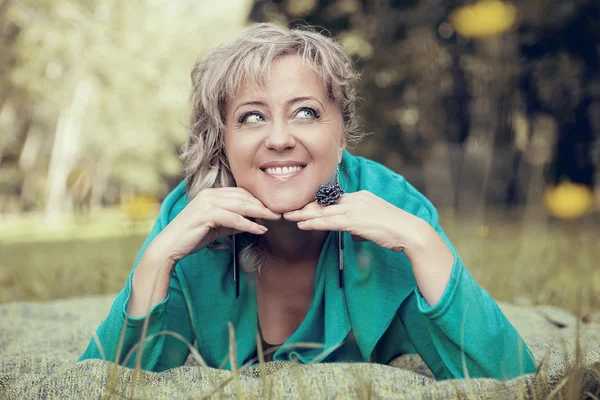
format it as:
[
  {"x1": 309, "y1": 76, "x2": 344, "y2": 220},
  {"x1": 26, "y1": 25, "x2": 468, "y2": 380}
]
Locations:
[{"x1": 399, "y1": 199, "x2": 536, "y2": 380}]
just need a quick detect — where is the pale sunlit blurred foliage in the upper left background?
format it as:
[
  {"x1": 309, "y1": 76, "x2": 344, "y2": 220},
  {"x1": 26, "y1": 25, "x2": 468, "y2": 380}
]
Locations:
[{"x1": 0, "y1": 0, "x2": 244, "y2": 212}]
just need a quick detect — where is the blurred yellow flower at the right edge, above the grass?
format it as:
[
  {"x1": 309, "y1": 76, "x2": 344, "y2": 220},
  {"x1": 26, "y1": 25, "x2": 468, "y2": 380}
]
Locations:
[{"x1": 545, "y1": 182, "x2": 594, "y2": 219}]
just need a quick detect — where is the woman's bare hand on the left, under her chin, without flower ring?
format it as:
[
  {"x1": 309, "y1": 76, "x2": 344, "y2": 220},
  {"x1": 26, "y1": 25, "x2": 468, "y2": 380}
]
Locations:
[{"x1": 152, "y1": 187, "x2": 281, "y2": 265}]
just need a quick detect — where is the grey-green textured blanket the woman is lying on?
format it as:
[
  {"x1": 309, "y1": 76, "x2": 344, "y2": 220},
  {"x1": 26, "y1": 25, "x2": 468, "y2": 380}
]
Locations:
[{"x1": 0, "y1": 296, "x2": 600, "y2": 399}]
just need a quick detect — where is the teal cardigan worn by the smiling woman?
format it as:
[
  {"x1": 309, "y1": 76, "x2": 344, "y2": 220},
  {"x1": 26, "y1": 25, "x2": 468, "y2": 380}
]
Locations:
[{"x1": 80, "y1": 152, "x2": 536, "y2": 379}]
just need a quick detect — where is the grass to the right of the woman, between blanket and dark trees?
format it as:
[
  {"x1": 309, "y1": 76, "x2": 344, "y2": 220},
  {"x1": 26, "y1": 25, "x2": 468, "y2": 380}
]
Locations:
[{"x1": 442, "y1": 212, "x2": 600, "y2": 316}]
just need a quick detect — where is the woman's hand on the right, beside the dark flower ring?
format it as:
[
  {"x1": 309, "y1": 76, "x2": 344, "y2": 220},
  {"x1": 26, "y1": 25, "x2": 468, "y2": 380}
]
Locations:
[{"x1": 283, "y1": 190, "x2": 432, "y2": 255}]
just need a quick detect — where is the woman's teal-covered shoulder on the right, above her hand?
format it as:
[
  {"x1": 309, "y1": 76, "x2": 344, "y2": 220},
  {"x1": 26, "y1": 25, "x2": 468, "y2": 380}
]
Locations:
[{"x1": 340, "y1": 151, "x2": 437, "y2": 222}]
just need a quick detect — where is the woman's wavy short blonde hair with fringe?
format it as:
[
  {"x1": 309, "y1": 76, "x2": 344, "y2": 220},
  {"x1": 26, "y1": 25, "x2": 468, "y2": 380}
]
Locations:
[{"x1": 181, "y1": 23, "x2": 363, "y2": 272}]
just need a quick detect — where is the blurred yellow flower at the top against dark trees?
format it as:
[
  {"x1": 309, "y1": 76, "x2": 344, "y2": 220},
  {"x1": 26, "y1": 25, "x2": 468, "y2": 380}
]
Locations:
[{"x1": 450, "y1": 0, "x2": 517, "y2": 38}]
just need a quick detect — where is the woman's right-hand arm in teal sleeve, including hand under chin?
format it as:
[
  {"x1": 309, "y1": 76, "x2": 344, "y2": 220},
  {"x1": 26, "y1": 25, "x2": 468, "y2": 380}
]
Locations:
[{"x1": 284, "y1": 165, "x2": 535, "y2": 379}]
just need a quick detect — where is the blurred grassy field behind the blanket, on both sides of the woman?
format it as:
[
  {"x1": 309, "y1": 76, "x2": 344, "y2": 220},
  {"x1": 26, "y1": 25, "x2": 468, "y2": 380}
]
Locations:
[{"x1": 0, "y1": 210, "x2": 600, "y2": 318}]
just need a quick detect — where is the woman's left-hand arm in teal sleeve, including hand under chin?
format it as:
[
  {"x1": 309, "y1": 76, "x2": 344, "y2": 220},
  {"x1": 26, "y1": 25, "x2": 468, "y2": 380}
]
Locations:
[{"x1": 80, "y1": 182, "x2": 281, "y2": 371}]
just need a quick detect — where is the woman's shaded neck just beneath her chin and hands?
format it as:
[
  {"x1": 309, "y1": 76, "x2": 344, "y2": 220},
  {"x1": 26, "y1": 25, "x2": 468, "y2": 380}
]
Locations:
[{"x1": 256, "y1": 218, "x2": 328, "y2": 266}]
